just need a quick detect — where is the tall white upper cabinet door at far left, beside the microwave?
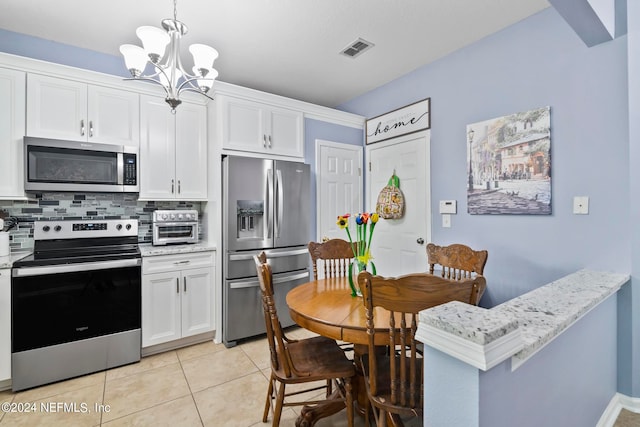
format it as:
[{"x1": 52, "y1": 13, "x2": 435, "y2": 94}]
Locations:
[{"x1": 0, "y1": 68, "x2": 26, "y2": 200}]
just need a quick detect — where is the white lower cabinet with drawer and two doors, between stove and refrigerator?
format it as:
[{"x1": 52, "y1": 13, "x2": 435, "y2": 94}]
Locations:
[{"x1": 142, "y1": 251, "x2": 215, "y2": 347}]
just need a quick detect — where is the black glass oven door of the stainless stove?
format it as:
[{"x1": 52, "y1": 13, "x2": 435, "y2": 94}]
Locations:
[{"x1": 11, "y1": 258, "x2": 141, "y2": 353}]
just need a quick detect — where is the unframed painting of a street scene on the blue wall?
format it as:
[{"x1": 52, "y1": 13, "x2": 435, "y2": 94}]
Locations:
[{"x1": 467, "y1": 107, "x2": 551, "y2": 215}]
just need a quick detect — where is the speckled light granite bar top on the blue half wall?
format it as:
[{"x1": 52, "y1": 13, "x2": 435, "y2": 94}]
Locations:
[{"x1": 419, "y1": 270, "x2": 629, "y2": 372}]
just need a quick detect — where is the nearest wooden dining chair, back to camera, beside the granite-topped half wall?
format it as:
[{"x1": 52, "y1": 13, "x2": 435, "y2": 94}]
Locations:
[{"x1": 358, "y1": 271, "x2": 486, "y2": 426}]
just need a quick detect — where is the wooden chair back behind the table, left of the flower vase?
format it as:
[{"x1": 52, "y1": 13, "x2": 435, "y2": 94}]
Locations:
[{"x1": 308, "y1": 239, "x2": 357, "y2": 280}]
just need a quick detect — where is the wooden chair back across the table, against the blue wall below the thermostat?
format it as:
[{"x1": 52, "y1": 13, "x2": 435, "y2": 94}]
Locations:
[{"x1": 427, "y1": 243, "x2": 489, "y2": 280}]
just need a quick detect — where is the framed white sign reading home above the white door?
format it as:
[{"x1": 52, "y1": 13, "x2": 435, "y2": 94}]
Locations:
[{"x1": 366, "y1": 98, "x2": 431, "y2": 145}]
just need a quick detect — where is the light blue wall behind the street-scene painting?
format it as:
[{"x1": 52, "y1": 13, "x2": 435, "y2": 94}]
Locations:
[{"x1": 340, "y1": 8, "x2": 630, "y2": 306}]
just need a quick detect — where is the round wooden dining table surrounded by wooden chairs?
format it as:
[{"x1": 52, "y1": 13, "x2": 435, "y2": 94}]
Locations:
[{"x1": 287, "y1": 277, "x2": 402, "y2": 346}]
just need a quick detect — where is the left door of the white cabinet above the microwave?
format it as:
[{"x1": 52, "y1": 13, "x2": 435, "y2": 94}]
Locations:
[{"x1": 27, "y1": 74, "x2": 89, "y2": 141}]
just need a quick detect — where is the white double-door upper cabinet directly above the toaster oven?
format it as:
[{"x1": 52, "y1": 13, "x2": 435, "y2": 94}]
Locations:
[{"x1": 140, "y1": 95, "x2": 207, "y2": 200}]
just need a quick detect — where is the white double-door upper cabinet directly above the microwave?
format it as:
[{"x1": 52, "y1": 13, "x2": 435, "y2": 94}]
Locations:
[{"x1": 27, "y1": 74, "x2": 140, "y2": 147}]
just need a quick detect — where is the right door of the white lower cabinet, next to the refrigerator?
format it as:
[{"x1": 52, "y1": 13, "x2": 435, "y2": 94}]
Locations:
[{"x1": 182, "y1": 268, "x2": 213, "y2": 337}]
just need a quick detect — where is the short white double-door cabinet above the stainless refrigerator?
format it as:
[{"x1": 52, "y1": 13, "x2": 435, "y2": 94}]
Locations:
[{"x1": 217, "y1": 95, "x2": 304, "y2": 158}]
